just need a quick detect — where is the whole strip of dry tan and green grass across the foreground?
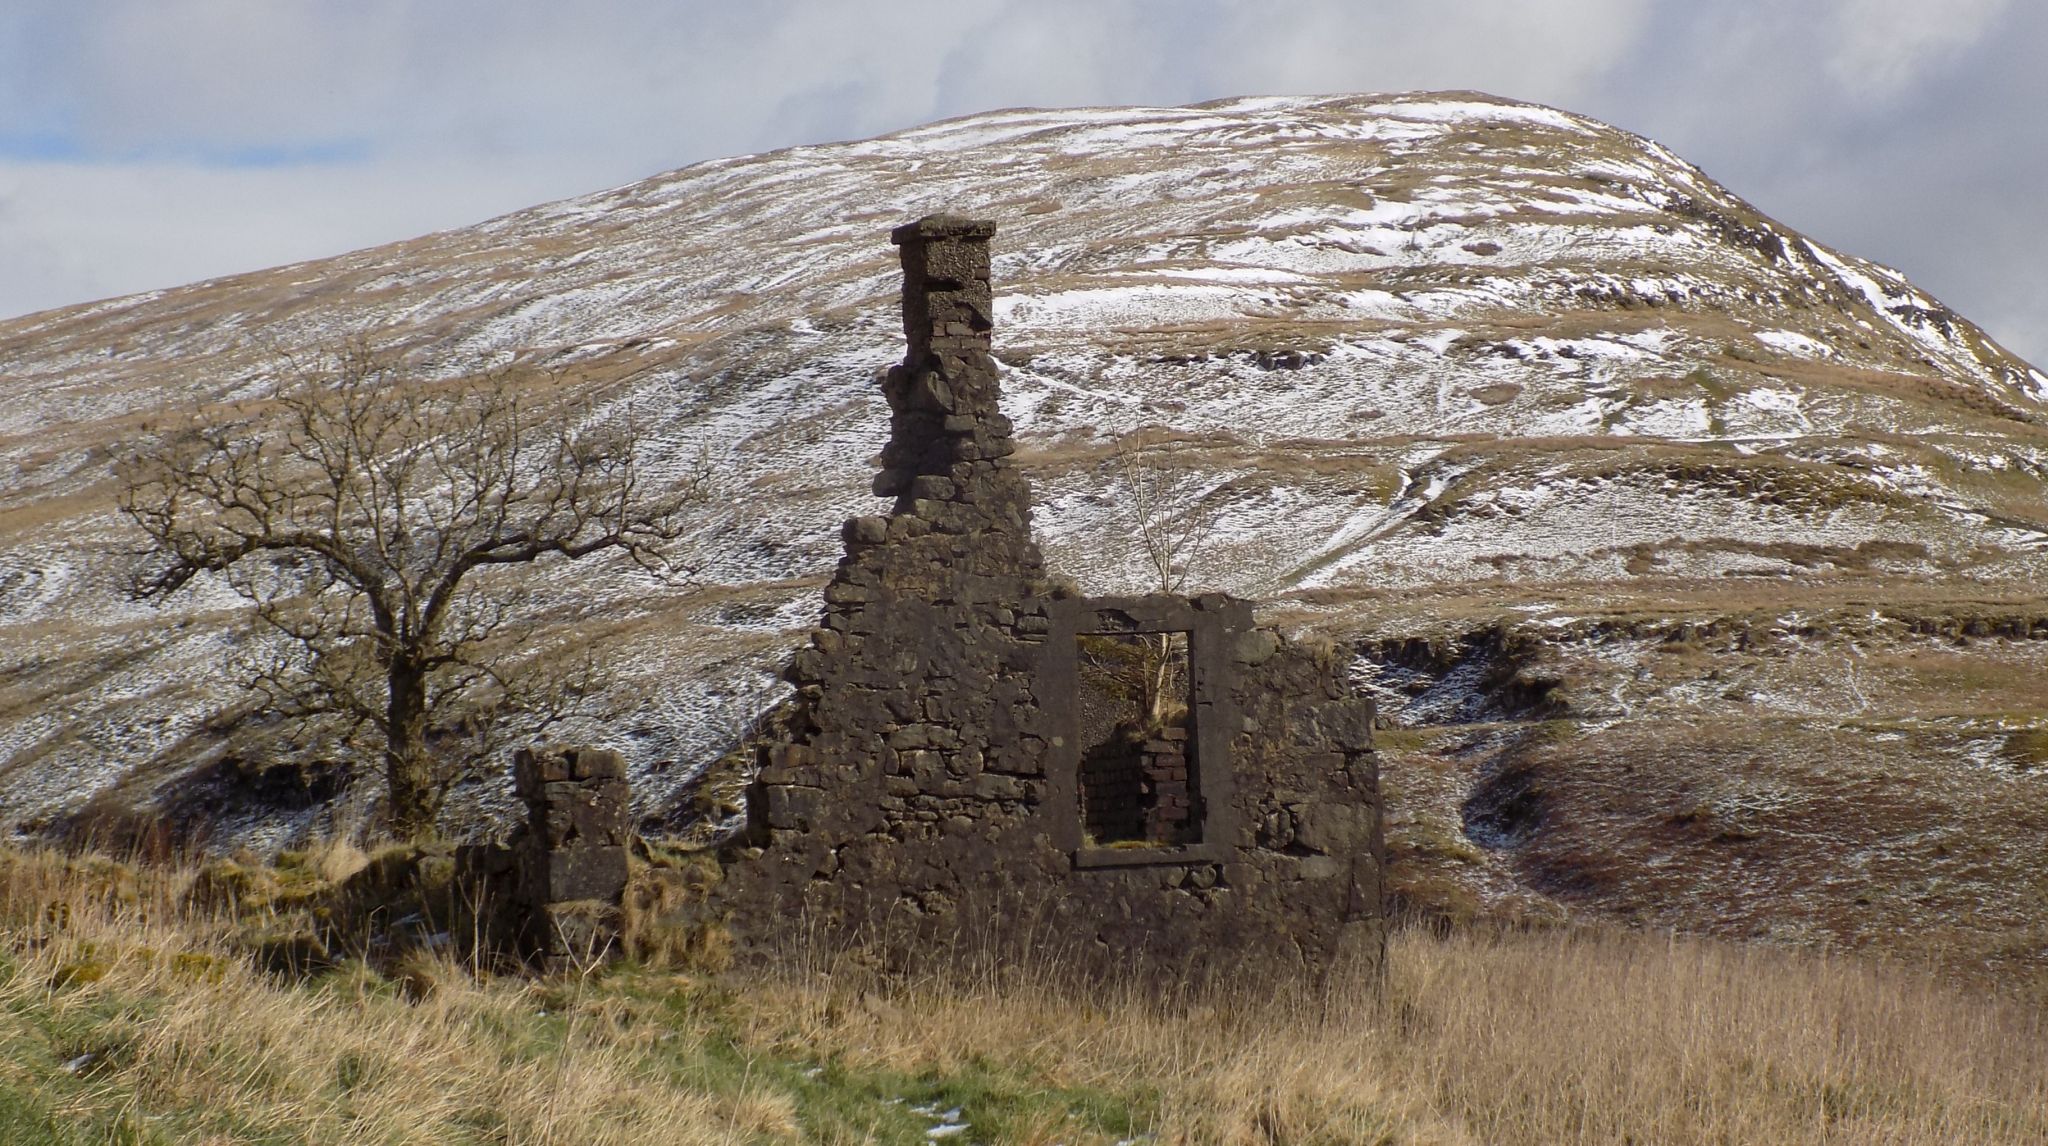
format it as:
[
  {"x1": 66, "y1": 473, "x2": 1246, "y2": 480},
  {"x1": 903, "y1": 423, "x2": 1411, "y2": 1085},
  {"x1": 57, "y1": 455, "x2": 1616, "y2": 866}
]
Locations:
[{"x1": 0, "y1": 853, "x2": 2048, "y2": 1146}]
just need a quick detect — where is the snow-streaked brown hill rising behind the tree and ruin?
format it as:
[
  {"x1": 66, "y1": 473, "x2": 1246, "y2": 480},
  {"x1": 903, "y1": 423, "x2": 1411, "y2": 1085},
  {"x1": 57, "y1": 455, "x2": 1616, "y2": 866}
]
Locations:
[{"x1": 0, "y1": 94, "x2": 2048, "y2": 920}]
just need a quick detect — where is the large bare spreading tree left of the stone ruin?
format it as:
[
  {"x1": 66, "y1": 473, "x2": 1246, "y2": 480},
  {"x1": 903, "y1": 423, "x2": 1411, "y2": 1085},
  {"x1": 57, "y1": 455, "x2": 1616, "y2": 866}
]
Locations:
[{"x1": 121, "y1": 348, "x2": 707, "y2": 835}]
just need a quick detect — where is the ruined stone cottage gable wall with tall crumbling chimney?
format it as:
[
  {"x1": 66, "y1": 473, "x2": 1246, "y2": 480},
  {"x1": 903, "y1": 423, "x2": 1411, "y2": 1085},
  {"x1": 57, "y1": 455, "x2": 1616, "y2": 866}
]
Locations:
[{"x1": 719, "y1": 215, "x2": 1384, "y2": 980}]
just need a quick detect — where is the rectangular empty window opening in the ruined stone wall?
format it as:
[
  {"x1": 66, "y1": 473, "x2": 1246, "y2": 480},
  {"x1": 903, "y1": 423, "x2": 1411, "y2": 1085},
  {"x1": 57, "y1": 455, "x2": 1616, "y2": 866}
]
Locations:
[{"x1": 1075, "y1": 632, "x2": 1202, "y2": 847}]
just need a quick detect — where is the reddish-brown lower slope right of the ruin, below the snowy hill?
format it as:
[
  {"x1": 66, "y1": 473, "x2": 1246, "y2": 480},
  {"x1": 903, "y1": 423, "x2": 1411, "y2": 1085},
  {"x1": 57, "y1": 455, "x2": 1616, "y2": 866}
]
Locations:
[{"x1": 1318, "y1": 585, "x2": 2048, "y2": 986}]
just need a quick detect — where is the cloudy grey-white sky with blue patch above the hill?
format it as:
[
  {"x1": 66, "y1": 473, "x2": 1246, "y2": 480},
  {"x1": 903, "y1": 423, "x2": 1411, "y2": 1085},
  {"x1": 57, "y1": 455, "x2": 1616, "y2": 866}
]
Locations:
[{"x1": 0, "y1": 0, "x2": 2048, "y2": 364}]
